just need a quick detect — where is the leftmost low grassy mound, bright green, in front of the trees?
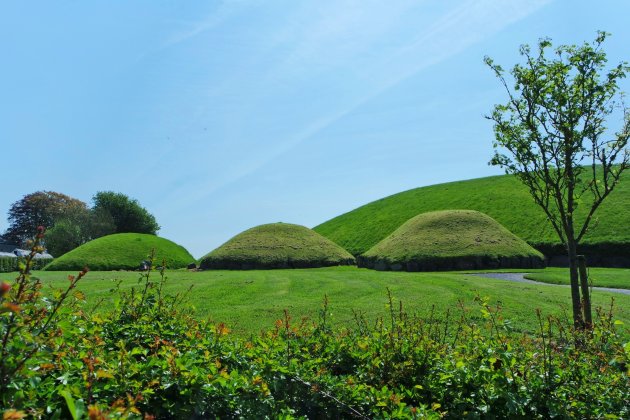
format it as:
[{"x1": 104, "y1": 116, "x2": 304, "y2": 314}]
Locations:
[{"x1": 44, "y1": 233, "x2": 195, "y2": 271}]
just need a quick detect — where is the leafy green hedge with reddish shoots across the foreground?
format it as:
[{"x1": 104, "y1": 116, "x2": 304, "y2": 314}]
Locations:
[{"x1": 0, "y1": 249, "x2": 630, "y2": 418}]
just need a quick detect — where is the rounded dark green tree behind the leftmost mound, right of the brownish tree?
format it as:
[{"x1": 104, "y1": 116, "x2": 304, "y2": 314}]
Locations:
[{"x1": 93, "y1": 191, "x2": 160, "y2": 235}]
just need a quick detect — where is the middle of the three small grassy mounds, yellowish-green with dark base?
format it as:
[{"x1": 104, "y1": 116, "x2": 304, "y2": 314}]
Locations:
[{"x1": 200, "y1": 223, "x2": 354, "y2": 270}]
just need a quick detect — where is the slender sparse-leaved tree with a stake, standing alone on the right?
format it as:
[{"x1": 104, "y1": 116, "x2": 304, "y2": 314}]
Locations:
[{"x1": 485, "y1": 32, "x2": 630, "y2": 327}]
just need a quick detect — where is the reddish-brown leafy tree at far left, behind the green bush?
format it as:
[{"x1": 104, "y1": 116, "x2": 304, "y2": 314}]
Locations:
[{"x1": 3, "y1": 191, "x2": 89, "y2": 245}]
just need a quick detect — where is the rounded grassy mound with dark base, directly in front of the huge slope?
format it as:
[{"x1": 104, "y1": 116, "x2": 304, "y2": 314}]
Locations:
[{"x1": 358, "y1": 210, "x2": 545, "y2": 271}]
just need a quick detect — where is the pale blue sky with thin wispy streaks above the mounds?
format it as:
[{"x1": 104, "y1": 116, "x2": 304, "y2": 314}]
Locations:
[{"x1": 0, "y1": 0, "x2": 630, "y2": 257}]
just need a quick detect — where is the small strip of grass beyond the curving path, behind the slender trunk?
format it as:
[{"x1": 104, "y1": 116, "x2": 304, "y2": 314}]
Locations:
[{"x1": 525, "y1": 267, "x2": 630, "y2": 289}]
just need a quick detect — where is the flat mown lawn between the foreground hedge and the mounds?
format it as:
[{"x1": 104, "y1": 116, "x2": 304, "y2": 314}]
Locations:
[{"x1": 11, "y1": 267, "x2": 630, "y2": 336}]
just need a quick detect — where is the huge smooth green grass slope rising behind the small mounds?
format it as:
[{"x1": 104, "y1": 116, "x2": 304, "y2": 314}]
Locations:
[{"x1": 313, "y1": 173, "x2": 630, "y2": 255}]
